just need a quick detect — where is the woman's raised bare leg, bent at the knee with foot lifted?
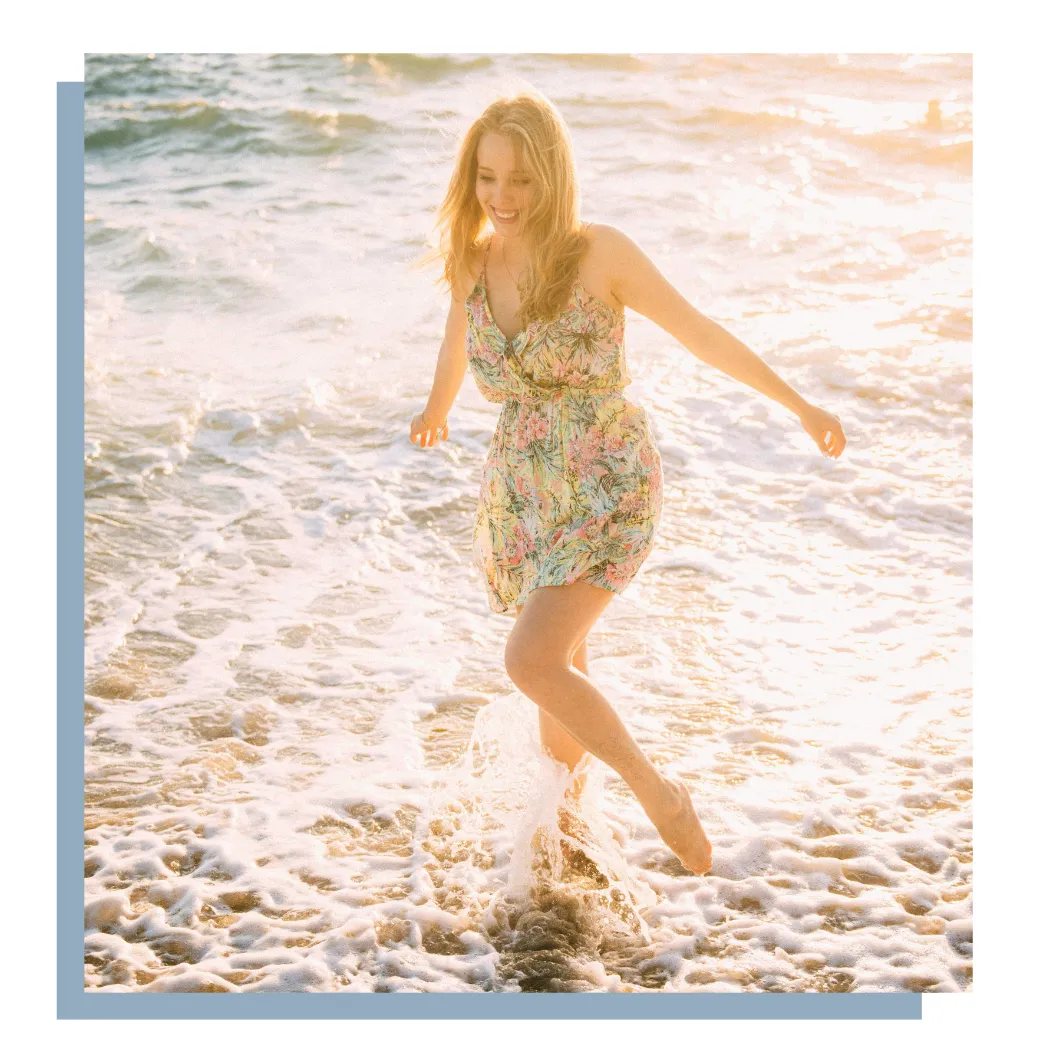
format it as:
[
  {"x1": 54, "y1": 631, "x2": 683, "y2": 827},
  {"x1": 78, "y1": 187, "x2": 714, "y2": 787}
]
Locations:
[{"x1": 506, "y1": 580, "x2": 712, "y2": 875}]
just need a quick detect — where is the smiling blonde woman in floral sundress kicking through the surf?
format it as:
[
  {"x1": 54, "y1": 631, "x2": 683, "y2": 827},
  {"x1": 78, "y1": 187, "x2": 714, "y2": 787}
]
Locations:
[{"x1": 409, "y1": 94, "x2": 845, "y2": 874}]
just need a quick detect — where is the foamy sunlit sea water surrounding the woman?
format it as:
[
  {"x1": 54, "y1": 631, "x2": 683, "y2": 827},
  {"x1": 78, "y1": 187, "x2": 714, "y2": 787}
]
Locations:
[{"x1": 85, "y1": 54, "x2": 973, "y2": 993}]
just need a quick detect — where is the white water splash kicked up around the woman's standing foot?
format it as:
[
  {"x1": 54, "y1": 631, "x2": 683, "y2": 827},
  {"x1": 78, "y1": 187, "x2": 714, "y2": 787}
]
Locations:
[{"x1": 415, "y1": 692, "x2": 658, "y2": 992}]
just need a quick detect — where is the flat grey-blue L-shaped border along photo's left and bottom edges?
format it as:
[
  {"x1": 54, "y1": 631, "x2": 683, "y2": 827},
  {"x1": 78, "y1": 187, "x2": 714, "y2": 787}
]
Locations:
[{"x1": 56, "y1": 82, "x2": 923, "y2": 1019}]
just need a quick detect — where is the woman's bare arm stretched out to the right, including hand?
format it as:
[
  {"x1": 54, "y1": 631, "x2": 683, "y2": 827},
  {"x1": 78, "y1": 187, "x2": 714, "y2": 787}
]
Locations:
[{"x1": 594, "y1": 225, "x2": 845, "y2": 458}]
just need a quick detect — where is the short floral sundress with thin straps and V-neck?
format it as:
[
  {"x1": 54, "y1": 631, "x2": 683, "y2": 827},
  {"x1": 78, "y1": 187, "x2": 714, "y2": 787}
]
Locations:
[{"x1": 466, "y1": 232, "x2": 662, "y2": 613}]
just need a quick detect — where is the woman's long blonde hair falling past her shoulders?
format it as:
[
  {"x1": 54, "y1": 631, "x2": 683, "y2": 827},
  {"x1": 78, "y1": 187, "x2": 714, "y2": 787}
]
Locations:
[{"x1": 422, "y1": 91, "x2": 587, "y2": 328}]
